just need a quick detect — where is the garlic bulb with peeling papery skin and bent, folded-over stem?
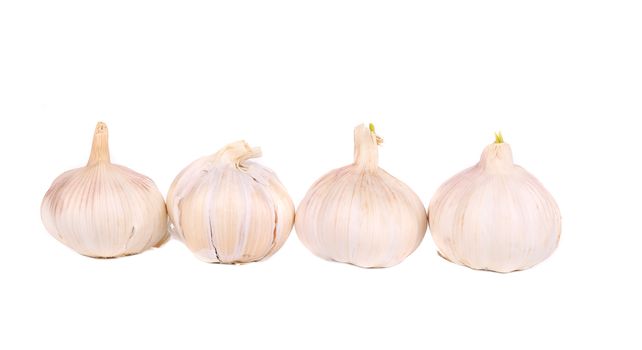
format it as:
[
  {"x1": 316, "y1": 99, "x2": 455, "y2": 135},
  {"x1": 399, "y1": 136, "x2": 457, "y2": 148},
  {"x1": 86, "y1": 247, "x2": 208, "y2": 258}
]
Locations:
[{"x1": 167, "y1": 141, "x2": 294, "y2": 264}]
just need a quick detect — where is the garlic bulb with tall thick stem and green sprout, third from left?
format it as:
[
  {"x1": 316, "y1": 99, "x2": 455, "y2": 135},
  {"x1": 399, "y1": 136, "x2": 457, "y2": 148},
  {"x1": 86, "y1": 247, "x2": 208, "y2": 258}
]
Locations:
[{"x1": 295, "y1": 124, "x2": 427, "y2": 267}]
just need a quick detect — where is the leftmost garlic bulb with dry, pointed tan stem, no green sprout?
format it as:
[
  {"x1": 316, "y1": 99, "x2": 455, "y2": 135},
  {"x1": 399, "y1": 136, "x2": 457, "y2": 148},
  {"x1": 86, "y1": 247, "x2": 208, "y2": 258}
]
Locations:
[{"x1": 41, "y1": 123, "x2": 169, "y2": 258}]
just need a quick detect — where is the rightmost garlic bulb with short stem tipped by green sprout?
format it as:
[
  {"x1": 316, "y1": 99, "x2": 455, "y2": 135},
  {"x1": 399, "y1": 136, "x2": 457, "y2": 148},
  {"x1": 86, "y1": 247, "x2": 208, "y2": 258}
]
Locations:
[{"x1": 428, "y1": 134, "x2": 561, "y2": 272}]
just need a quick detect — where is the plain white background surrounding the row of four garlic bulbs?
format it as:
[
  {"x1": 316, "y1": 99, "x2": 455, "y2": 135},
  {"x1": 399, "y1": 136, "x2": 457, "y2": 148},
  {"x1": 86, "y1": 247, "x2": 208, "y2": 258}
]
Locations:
[{"x1": 0, "y1": 0, "x2": 642, "y2": 349}]
